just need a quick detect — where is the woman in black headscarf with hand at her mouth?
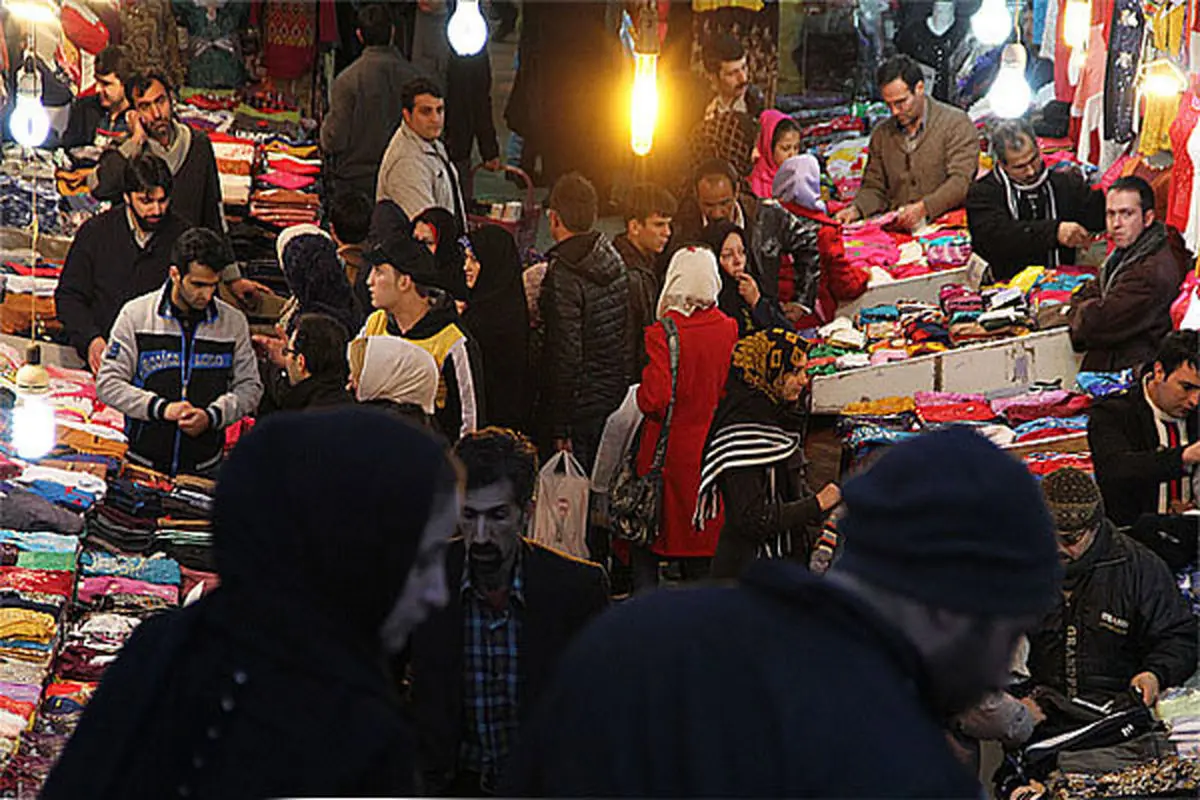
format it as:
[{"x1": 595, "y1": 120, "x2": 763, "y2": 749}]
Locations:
[{"x1": 703, "y1": 222, "x2": 792, "y2": 336}]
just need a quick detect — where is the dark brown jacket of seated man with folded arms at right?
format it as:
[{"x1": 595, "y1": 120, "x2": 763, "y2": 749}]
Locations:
[{"x1": 1067, "y1": 222, "x2": 1193, "y2": 372}]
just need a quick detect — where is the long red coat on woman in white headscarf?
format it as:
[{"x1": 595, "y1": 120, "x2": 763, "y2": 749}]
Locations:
[{"x1": 637, "y1": 308, "x2": 738, "y2": 558}]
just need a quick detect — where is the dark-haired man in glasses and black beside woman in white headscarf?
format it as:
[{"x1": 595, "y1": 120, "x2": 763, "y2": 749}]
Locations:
[{"x1": 254, "y1": 312, "x2": 354, "y2": 417}]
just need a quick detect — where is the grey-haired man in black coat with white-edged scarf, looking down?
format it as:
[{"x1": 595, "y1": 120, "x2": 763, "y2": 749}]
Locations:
[{"x1": 967, "y1": 120, "x2": 1104, "y2": 281}]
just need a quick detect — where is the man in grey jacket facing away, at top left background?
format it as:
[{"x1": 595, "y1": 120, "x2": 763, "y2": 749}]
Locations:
[{"x1": 320, "y1": 4, "x2": 420, "y2": 197}]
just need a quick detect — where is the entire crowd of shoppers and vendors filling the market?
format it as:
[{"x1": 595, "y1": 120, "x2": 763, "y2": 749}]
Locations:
[{"x1": 18, "y1": 6, "x2": 1200, "y2": 798}]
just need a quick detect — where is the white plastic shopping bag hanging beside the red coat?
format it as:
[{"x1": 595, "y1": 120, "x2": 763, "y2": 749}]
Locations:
[{"x1": 533, "y1": 452, "x2": 589, "y2": 559}]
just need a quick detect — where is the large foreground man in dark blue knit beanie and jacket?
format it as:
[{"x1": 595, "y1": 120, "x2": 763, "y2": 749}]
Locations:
[{"x1": 503, "y1": 427, "x2": 1060, "y2": 798}]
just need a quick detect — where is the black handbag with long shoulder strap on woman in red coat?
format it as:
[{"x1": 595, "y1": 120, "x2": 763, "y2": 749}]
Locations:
[{"x1": 608, "y1": 317, "x2": 679, "y2": 547}]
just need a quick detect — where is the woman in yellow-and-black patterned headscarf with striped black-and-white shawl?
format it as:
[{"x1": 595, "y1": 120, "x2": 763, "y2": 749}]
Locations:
[{"x1": 692, "y1": 327, "x2": 841, "y2": 578}]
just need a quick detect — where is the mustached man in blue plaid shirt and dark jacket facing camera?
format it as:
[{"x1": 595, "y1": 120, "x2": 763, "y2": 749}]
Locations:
[{"x1": 412, "y1": 428, "x2": 608, "y2": 798}]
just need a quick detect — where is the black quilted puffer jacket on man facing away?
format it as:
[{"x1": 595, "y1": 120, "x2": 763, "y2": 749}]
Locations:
[{"x1": 538, "y1": 231, "x2": 634, "y2": 439}]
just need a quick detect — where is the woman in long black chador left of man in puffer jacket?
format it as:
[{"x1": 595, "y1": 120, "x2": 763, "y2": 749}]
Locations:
[{"x1": 462, "y1": 225, "x2": 529, "y2": 431}]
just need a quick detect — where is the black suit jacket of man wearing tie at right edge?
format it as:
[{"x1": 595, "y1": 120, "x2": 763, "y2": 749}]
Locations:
[{"x1": 1087, "y1": 385, "x2": 1200, "y2": 527}]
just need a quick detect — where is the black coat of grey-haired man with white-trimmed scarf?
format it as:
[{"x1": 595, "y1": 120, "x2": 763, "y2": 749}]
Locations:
[{"x1": 967, "y1": 167, "x2": 1104, "y2": 281}]
